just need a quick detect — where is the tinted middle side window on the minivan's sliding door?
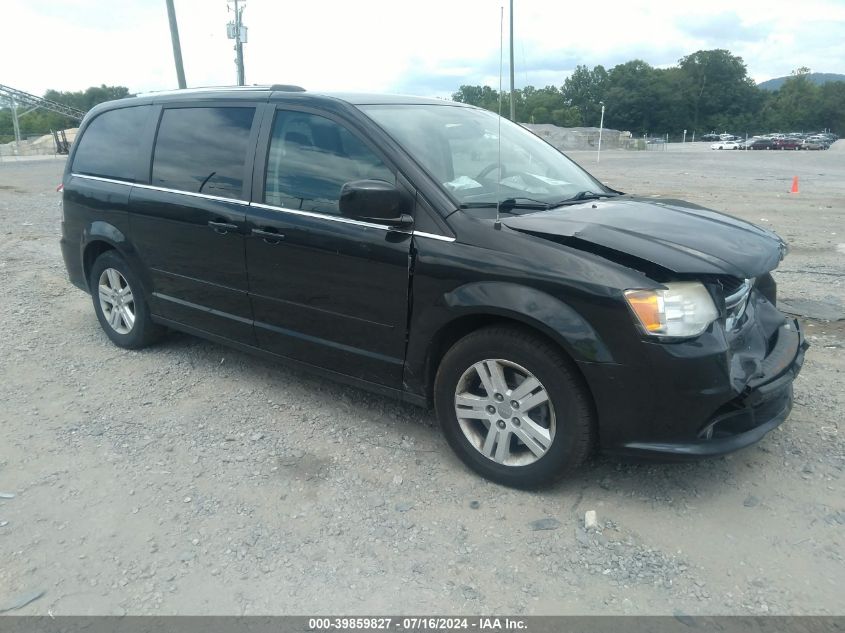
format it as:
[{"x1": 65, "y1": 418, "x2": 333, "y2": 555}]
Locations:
[{"x1": 152, "y1": 107, "x2": 255, "y2": 198}]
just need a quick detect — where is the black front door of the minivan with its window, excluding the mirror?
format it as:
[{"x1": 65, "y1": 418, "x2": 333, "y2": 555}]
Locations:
[{"x1": 246, "y1": 109, "x2": 411, "y2": 388}]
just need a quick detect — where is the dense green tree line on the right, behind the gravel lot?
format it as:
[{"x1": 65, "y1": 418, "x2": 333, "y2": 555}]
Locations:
[{"x1": 452, "y1": 49, "x2": 845, "y2": 138}]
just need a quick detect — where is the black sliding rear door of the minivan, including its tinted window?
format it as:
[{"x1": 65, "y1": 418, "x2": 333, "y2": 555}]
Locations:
[{"x1": 130, "y1": 104, "x2": 258, "y2": 344}]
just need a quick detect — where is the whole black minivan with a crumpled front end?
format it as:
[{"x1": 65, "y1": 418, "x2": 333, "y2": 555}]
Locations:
[{"x1": 61, "y1": 86, "x2": 807, "y2": 487}]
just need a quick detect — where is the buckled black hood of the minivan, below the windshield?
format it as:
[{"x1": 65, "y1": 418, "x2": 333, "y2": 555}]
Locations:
[{"x1": 502, "y1": 196, "x2": 786, "y2": 278}]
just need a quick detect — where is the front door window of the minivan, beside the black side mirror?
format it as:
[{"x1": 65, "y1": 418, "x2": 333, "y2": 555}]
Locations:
[{"x1": 264, "y1": 110, "x2": 396, "y2": 214}]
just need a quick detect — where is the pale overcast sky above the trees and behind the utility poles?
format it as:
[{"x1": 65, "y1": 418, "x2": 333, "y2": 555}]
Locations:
[{"x1": 6, "y1": 0, "x2": 845, "y2": 96}]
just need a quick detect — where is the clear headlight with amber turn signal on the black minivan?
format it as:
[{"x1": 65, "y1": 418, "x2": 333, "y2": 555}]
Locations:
[{"x1": 625, "y1": 281, "x2": 719, "y2": 336}]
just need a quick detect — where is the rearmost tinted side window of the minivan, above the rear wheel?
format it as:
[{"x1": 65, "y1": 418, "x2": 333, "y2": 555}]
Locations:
[{"x1": 72, "y1": 106, "x2": 149, "y2": 182}]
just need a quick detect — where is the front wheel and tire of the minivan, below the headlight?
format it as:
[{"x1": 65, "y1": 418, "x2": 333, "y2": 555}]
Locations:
[{"x1": 434, "y1": 326, "x2": 595, "y2": 488}]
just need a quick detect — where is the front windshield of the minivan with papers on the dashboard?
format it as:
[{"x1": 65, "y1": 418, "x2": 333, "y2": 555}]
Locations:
[{"x1": 359, "y1": 105, "x2": 608, "y2": 207}]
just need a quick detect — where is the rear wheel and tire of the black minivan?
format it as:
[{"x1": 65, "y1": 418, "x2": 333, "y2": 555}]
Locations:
[{"x1": 88, "y1": 251, "x2": 162, "y2": 349}]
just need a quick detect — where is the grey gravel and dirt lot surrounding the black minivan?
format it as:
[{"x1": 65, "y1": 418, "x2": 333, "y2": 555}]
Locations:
[{"x1": 0, "y1": 141, "x2": 845, "y2": 615}]
